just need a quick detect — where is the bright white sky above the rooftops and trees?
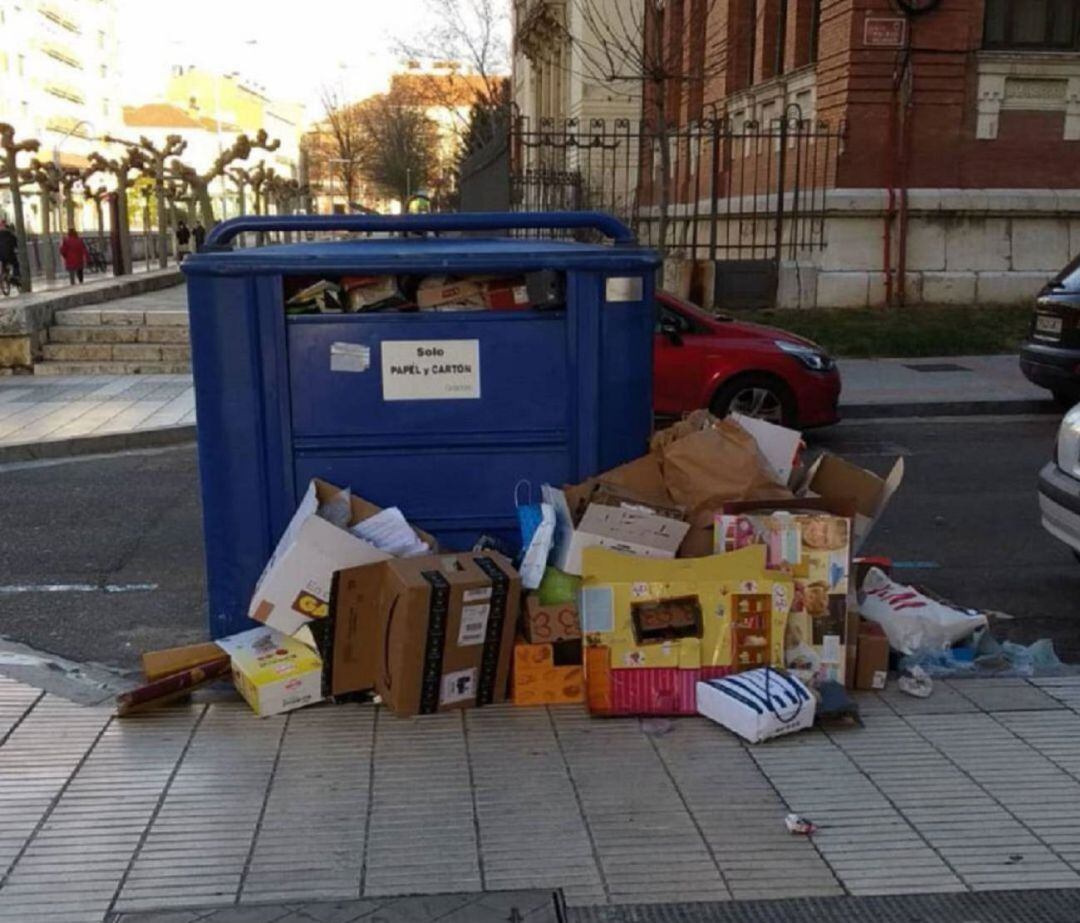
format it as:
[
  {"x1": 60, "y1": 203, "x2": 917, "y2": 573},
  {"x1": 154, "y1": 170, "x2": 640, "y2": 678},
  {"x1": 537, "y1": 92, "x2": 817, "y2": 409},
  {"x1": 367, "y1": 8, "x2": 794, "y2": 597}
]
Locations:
[{"x1": 118, "y1": 0, "x2": 438, "y2": 121}]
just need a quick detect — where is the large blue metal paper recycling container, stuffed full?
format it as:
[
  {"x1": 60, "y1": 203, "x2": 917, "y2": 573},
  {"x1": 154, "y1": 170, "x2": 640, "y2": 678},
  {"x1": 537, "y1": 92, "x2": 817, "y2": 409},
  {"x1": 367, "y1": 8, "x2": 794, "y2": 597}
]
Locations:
[{"x1": 183, "y1": 213, "x2": 659, "y2": 637}]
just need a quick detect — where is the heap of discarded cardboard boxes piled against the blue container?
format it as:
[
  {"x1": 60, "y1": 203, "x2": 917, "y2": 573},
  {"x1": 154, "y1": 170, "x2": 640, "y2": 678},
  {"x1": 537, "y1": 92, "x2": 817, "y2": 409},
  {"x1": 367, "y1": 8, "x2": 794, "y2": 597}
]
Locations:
[{"x1": 120, "y1": 411, "x2": 993, "y2": 739}]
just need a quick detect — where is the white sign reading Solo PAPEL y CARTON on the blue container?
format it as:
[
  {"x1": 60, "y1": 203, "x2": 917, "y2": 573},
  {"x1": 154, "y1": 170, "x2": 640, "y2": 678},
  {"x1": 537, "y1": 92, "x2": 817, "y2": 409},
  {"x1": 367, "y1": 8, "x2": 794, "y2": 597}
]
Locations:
[{"x1": 381, "y1": 340, "x2": 480, "y2": 401}]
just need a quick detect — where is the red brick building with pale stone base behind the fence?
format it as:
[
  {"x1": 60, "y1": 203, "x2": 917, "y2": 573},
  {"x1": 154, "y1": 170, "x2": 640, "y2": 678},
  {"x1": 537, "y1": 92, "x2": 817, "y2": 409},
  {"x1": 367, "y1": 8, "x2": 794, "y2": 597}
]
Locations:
[{"x1": 643, "y1": 0, "x2": 1080, "y2": 307}]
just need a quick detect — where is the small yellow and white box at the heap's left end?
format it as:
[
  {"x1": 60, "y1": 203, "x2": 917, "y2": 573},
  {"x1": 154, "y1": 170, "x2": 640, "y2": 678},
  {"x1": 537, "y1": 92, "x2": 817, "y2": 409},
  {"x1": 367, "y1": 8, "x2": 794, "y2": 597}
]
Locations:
[{"x1": 217, "y1": 627, "x2": 323, "y2": 718}]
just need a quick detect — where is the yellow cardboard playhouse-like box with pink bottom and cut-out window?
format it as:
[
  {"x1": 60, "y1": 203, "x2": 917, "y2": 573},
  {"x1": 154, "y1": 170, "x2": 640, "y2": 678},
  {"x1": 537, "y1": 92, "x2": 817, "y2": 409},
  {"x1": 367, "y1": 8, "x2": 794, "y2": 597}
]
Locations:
[{"x1": 580, "y1": 545, "x2": 794, "y2": 715}]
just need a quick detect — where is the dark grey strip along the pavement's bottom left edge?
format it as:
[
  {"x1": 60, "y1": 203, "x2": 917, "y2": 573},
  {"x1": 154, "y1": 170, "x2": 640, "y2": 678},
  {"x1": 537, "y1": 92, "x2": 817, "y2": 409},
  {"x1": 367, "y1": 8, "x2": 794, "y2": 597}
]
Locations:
[{"x1": 108, "y1": 891, "x2": 566, "y2": 923}]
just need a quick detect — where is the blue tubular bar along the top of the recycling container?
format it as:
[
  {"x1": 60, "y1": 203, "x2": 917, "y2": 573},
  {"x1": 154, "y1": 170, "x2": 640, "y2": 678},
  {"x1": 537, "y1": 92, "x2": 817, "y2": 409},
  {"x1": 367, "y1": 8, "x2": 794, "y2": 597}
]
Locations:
[{"x1": 205, "y1": 212, "x2": 636, "y2": 247}]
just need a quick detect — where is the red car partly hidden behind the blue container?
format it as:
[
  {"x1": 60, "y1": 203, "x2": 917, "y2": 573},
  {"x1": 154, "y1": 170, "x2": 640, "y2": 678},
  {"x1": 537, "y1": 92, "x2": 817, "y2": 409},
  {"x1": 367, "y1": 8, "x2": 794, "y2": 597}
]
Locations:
[{"x1": 652, "y1": 291, "x2": 840, "y2": 430}]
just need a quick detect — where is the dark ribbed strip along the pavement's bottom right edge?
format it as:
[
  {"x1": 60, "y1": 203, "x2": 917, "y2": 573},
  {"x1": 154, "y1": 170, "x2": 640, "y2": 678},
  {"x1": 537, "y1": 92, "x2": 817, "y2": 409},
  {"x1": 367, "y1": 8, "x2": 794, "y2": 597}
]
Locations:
[{"x1": 568, "y1": 890, "x2": 1080, "y2": 923}]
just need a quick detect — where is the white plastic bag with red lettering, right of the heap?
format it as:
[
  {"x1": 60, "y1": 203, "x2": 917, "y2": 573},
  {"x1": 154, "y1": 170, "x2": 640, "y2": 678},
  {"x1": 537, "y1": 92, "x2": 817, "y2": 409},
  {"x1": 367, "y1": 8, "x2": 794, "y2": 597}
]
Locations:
[{"x1": 859, "y1": 567, "x2": 986, "y2": 654}]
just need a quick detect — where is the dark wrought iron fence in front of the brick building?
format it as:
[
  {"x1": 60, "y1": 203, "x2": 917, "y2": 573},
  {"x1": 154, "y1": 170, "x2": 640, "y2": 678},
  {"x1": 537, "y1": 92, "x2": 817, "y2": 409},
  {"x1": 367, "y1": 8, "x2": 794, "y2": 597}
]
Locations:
[{"x1": 510, "y1": 105, "x2": 845, "y2": 260}]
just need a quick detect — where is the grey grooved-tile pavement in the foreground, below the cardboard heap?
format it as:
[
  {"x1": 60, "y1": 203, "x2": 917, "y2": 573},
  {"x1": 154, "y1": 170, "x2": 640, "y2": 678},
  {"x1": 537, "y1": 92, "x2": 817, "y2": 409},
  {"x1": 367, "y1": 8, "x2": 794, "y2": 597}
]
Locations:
[{"x1": 0, "y1": 677, "x2": 1080, "y2": 923}]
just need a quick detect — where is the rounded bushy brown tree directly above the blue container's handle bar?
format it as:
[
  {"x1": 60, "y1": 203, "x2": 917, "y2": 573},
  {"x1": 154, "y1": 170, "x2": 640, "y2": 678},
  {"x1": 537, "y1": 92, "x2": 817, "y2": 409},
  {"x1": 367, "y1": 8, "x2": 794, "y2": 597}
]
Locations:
[{"x1": 360, "y1": 93, "x2": 440, "y2": 211}]
